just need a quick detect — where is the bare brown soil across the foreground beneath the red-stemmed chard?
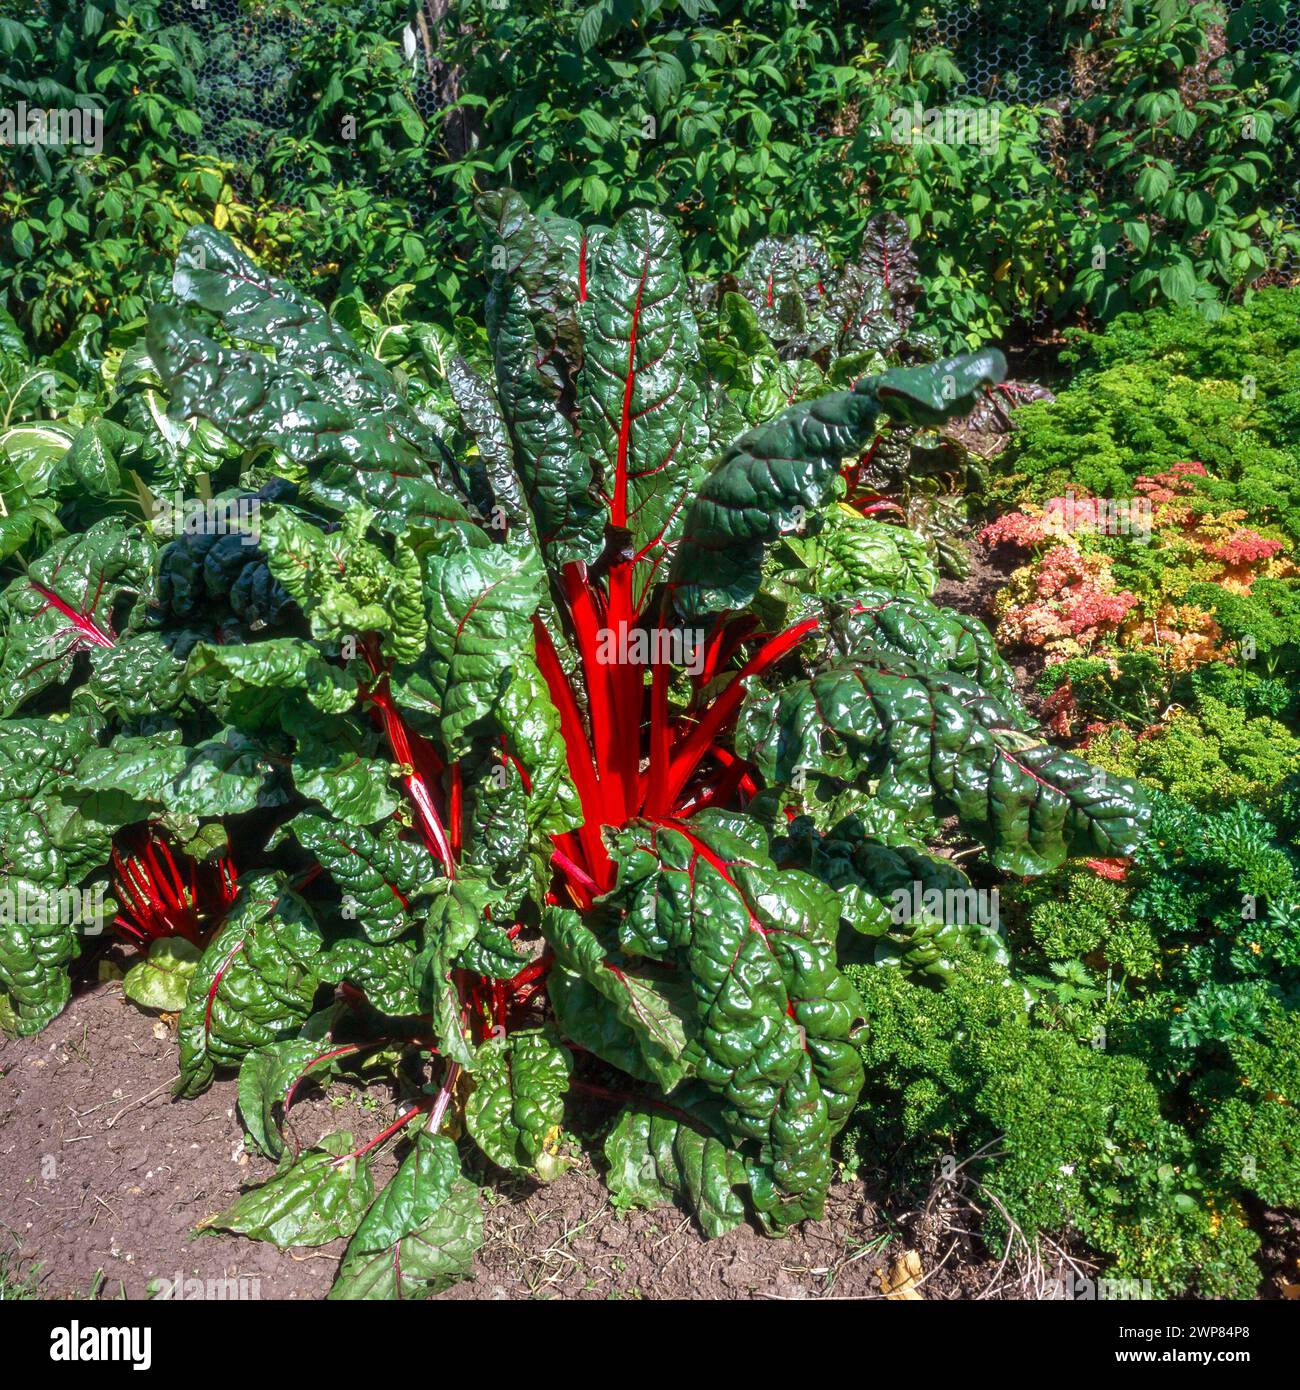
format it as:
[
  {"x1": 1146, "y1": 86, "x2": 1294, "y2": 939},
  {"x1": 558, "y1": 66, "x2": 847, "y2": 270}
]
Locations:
[{"x1": 0, "y1": 981, "x2": 1023, "y2": 1298}]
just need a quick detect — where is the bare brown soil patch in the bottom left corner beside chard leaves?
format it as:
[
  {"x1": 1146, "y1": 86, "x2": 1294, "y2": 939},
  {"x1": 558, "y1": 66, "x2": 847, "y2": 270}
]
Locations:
[{"x1": 0, "y1": 983, "x2": 340, "y2": 1298}]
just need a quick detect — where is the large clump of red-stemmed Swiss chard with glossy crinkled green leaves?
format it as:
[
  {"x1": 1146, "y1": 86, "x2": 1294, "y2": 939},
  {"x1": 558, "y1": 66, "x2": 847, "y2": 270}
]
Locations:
[{"x1": 0, "y1": 193, "x2": 1147, "y2": 1298}]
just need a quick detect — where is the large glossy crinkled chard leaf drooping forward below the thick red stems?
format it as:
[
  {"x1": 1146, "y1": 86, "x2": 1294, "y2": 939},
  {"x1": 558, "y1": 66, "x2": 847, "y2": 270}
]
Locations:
[{"x1": 609, "y1": 810, "x2": 862, "y2": 1226}]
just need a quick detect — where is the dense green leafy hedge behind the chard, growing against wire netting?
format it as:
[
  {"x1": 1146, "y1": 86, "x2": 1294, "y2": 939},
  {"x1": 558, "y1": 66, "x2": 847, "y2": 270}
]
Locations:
[{"x1": 0, "y1": 0, "x2": 1300, "y2": 358}]
